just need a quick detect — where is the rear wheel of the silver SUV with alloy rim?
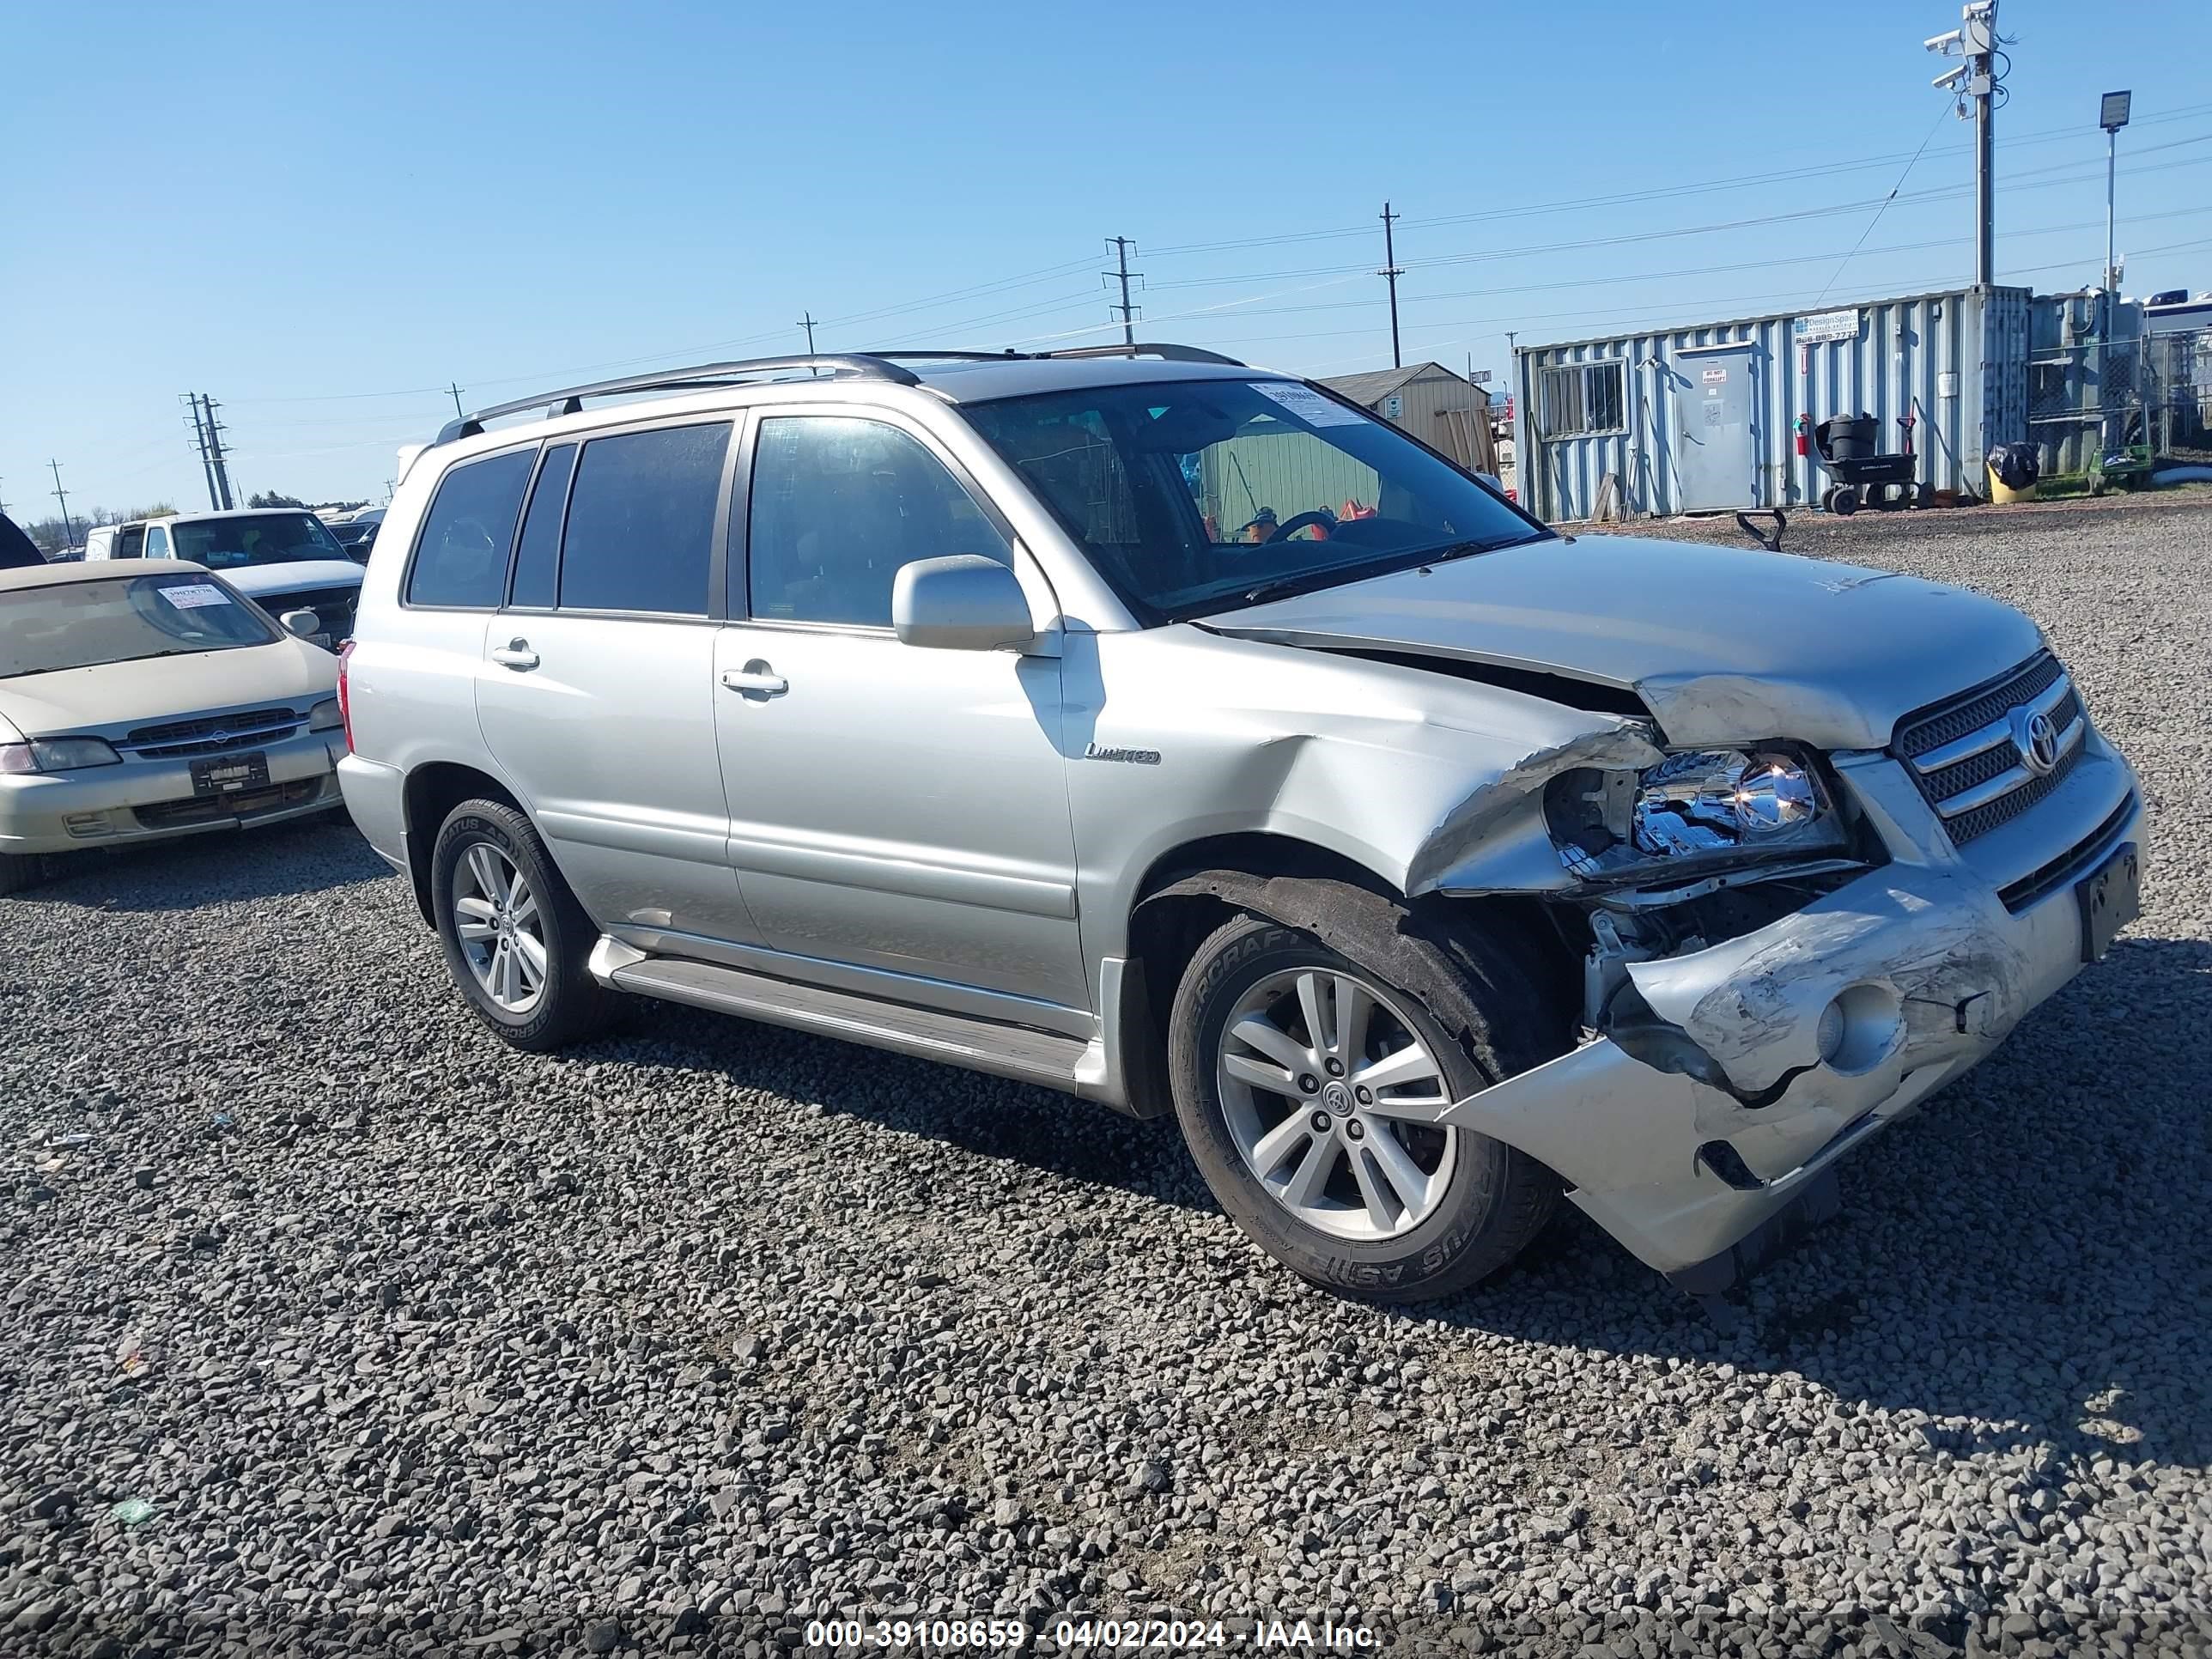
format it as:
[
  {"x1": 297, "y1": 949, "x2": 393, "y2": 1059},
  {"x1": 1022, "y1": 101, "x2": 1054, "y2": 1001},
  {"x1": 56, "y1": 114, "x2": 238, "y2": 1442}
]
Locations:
[{"x1": 429, "y1": 801, "x2": 622, "y2": 1053}]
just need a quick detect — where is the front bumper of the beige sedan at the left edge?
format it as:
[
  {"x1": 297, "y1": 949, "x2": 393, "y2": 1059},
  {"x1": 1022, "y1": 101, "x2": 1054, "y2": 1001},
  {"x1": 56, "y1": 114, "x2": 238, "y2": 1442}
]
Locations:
[{"x1": 0, "y1": 732, "x2": 343, "y2": 854}]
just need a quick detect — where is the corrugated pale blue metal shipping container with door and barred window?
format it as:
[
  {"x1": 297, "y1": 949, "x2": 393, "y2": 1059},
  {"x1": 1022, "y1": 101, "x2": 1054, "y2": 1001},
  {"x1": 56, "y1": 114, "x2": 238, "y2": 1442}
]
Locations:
[{"x1": 1513, "y1": 288, "x2": 2028, "y2": 522}]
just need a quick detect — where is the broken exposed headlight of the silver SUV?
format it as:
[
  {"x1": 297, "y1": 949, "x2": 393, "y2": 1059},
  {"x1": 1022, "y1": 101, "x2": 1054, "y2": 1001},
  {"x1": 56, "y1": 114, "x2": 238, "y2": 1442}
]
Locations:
[{"x1": 1544, "y1": 748, "x2": 1844, "y2": 880}]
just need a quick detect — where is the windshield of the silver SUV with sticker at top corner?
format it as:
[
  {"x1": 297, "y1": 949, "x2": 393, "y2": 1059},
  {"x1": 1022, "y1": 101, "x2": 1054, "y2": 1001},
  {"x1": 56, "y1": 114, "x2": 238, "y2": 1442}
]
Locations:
[{"x1": 963, "y1": 380, "x2": 1551, "y2": 622}]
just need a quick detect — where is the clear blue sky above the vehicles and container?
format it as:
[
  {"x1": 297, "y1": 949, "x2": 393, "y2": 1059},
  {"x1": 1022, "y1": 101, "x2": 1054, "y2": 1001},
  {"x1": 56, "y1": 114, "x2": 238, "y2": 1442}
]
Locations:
[{"x1": 0, "y1": 0, "x2": 2212, "y2": 520}]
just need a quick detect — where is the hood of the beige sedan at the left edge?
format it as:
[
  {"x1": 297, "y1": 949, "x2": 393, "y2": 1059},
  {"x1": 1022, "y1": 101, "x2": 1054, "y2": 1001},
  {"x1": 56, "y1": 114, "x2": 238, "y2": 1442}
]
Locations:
[{"x1": 0, "y1": 639, "x2": 338, "y2": 737}]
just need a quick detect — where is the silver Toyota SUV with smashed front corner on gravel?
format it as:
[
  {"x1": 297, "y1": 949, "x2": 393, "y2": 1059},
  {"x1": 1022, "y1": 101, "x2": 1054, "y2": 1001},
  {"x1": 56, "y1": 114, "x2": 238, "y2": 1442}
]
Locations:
[{"x1": 341, "y1": 347, "x2": 2143, "y2": 1301}]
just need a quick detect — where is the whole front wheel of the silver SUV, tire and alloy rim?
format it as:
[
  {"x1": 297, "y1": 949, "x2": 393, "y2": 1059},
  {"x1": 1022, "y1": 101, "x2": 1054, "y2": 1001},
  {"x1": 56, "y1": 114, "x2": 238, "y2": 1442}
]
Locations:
[{"x1": 1168, "y1": 894, "x2": 1559, "y2": 1303}]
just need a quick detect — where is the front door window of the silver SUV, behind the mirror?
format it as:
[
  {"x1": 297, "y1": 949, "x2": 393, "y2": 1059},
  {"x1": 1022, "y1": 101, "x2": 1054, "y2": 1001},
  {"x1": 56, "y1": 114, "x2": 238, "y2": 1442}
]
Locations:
[{"x1": 745, "y1": 416, "x2": 1013, "y2": 629}]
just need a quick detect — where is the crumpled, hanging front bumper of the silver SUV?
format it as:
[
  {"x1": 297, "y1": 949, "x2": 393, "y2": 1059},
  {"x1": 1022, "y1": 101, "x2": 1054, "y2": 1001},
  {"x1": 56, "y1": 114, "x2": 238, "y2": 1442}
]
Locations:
[{"x1": 1444, "y1": 738, "x2": 2143, "y2": 1294}]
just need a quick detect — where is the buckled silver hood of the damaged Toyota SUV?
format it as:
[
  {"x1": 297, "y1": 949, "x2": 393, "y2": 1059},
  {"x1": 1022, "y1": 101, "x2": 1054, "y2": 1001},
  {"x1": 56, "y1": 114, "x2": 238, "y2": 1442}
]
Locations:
[{"x1": 1203, "y1": 535, "x2": 2042, "y2": 750}]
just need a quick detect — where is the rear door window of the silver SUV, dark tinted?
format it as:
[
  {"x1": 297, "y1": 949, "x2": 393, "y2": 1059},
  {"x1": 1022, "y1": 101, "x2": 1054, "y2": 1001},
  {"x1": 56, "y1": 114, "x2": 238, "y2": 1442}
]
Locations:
[{"x1": 557, "y1": 422, "x2": 730, "y2": 617}]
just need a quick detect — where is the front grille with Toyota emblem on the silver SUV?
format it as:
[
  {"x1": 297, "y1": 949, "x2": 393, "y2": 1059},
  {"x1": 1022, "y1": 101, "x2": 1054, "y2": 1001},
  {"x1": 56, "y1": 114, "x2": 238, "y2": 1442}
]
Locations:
[{"x1": 1891, "y1": 650, "x2": 2088, "y2": 845}]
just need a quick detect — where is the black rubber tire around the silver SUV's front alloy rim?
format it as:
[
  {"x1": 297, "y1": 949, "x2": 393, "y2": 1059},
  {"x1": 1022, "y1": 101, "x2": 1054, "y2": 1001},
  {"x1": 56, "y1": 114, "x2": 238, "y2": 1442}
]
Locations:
[{"x1": 1168, "y1": 915, "x2": 1517, "y2": 1301}]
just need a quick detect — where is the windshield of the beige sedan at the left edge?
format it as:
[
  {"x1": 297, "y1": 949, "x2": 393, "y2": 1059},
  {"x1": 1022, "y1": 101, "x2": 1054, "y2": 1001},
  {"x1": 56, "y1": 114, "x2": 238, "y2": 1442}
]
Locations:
[{"x1": 0, "y1": 571, "x2": 276, "y2": 679}]
